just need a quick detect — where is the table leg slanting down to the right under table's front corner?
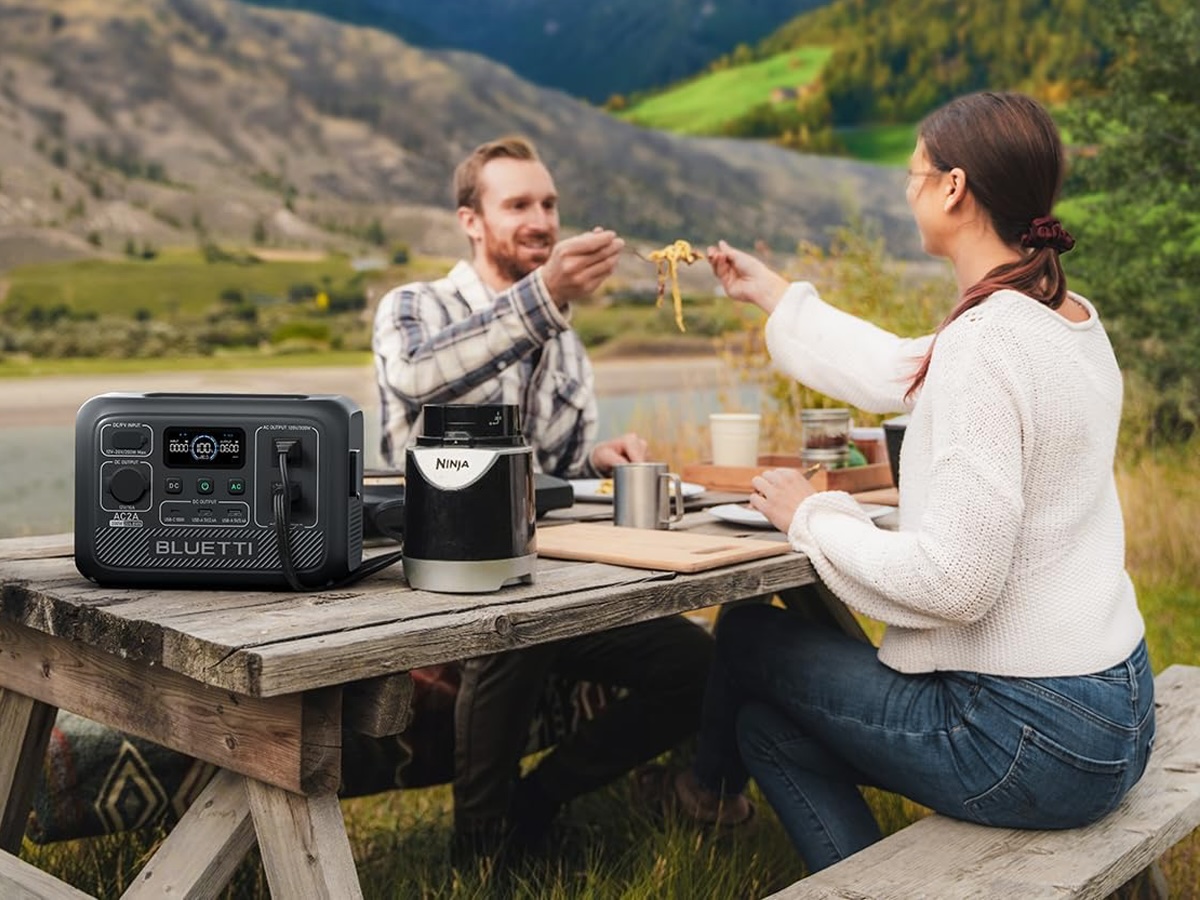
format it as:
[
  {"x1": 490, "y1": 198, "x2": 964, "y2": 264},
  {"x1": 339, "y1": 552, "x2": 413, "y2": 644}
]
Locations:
[{"x1": 246, "y1": 778, "x2": 362, "y2": 900}]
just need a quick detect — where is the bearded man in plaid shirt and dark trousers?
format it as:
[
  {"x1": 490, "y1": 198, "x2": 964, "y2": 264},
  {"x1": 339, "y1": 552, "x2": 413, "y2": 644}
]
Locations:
[{"x1": 374, "y1": 138, "x2": 712, "y2": 854}]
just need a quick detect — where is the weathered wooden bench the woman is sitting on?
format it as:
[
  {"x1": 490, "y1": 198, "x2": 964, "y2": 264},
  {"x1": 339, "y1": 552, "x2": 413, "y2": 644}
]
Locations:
[{"x1": 769, "y1": 666, "x2": 1200, "y2": 900}]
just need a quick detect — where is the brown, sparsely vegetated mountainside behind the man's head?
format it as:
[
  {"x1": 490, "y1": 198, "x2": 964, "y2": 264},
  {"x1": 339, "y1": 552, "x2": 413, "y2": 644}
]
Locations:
[{"x1": 0, "y1": 0, "x2": 916, "y2": 268}]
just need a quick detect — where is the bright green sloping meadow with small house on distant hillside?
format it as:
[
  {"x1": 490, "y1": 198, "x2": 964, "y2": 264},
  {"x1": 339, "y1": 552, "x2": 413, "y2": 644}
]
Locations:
[{"x1": 618, "y1": 47, "x2": 833, "y2": 134}]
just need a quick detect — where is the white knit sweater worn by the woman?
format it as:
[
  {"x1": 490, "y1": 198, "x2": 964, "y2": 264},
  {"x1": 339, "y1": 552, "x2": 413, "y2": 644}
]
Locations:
[{"x1": 767, "y1": 282, "x2": 1145, "y2": 677}]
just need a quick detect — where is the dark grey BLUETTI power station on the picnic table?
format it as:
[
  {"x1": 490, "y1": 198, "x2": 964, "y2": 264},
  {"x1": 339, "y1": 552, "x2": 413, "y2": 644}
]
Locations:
[{"x1": 74, "y1": 394, "x2": 364, "y2": 589}]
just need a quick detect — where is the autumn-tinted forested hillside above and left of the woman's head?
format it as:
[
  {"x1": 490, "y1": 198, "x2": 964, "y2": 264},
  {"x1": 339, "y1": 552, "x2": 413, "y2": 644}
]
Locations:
[{"x1": 626, "y1": 0, "x2": 1161, "y2": 152}]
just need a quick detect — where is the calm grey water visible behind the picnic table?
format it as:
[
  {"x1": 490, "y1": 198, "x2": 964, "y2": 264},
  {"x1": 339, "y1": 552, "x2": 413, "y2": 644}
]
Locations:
[{"x1": 0, "y1": 388, "x2": 758, "y2": 538}]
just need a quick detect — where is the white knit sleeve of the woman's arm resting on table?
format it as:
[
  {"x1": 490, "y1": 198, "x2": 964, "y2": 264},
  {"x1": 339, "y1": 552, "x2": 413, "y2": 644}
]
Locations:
[{"x1": 788, "y1": 320, "x2": 1028, "y2": 628}]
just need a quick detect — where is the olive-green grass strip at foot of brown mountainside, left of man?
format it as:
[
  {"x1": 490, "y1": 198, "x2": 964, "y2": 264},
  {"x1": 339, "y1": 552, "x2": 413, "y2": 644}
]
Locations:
[{"x1": 4, "y1": 250, "x2": 354, "y2": 318}]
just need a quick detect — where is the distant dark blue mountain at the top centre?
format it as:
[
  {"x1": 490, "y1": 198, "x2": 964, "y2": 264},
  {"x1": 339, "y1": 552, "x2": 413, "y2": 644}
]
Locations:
[{"x1": 247, "y1": 0, "x2": 829, "y2": 103}]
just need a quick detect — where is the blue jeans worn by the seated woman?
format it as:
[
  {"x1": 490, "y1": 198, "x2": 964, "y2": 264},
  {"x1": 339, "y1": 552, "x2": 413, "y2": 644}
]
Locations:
[{"x1": 694, "y1": 605, "x2": 1154, "y2": 871}]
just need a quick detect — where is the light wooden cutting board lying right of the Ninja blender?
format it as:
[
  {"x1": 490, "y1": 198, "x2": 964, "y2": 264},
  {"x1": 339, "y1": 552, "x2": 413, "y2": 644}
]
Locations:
[{"x1": 538, "y1": 522, "x2": 792, "y2": 572}]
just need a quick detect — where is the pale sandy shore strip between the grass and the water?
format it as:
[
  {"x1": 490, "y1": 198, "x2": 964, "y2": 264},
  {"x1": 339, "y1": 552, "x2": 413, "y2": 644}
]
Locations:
[{"x1": 0, "y1": 356, "x2": 722, "y2": 427}]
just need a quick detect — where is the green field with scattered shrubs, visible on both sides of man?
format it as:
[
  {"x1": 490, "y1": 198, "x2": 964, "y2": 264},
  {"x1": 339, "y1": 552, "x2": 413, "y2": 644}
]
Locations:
[{"x1": 0, "y1": 250, "x2": 739, "y2": 369}]
